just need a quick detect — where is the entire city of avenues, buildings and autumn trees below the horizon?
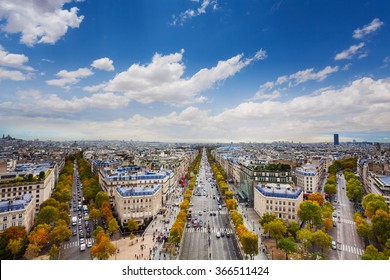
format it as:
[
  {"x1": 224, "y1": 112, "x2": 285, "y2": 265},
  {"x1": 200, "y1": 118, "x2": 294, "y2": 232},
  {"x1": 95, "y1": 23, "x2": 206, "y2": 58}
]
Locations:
[{"x1": 0, "y1": 134, "x2": 390, "y2": 260}]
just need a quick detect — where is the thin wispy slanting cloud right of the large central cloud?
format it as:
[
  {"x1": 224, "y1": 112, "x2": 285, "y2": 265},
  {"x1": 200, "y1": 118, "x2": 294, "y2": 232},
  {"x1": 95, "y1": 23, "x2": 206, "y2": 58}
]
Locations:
[{"x1": 253, "y1": 66, "x2": 339, "y2": 100}]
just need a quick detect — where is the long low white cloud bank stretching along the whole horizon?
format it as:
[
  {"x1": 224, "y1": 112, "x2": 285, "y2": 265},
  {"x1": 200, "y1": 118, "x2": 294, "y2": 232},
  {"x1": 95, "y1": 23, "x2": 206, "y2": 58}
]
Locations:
[{"x1": 0, "y1": 78, "x2": 390, "y2": 142}]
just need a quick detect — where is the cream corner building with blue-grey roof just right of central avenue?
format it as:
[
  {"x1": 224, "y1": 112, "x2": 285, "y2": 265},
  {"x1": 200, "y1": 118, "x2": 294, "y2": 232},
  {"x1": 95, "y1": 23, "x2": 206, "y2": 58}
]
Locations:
[{"x1": 253, "y1": 183, "x2": 303, "y2": 223}]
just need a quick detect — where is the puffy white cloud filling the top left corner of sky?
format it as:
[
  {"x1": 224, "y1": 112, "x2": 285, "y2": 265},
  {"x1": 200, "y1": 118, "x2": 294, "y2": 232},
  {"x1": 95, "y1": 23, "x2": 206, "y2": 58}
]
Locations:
[{"x1": 0, "y1": 0, "x2": 84, "y2": 46}]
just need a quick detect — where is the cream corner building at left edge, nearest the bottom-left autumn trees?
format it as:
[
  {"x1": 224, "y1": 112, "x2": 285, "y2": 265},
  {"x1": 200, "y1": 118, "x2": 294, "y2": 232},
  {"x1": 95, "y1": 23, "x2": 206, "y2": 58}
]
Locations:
[{"x1": 0, "y1": 194, "x2": 35, "y2": 232}]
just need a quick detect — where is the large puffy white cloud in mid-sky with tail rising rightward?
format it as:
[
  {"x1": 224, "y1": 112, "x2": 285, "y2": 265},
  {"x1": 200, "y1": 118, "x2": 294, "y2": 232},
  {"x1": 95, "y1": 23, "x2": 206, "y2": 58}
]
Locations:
[{"x1": 104, "y1": 50, "x2": 266, "y2": 105}]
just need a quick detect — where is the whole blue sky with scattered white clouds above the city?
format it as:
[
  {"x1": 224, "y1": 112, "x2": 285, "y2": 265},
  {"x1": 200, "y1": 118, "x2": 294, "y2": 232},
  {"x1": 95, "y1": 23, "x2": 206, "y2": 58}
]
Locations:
[{"x1": 0, "y1": 0, "x2": 390, "y2": 142}]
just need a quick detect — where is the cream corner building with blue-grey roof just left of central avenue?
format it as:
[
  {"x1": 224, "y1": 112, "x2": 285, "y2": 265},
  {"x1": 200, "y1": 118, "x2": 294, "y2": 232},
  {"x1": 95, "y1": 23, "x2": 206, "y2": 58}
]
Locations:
[{"x1": 114, "y1": 184, "x2": 162, "y2": 225}]
